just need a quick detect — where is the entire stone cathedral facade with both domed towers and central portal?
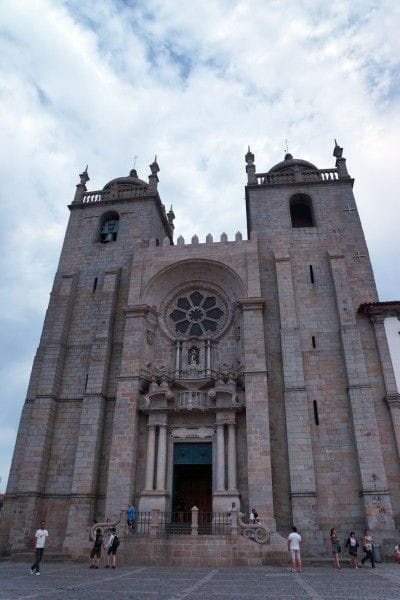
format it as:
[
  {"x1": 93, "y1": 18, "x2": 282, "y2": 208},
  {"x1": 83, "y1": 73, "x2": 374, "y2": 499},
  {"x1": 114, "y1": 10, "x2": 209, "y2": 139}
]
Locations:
[{"x1": 0, "y1": 144, "x2": 400, "y2": 554}]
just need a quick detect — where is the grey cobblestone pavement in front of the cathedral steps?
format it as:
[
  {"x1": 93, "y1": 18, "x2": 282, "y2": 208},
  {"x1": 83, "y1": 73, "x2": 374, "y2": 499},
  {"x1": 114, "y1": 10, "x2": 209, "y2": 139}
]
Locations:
[{"x1": 0, "y1": 562, "x2": 400, "y2": 600}]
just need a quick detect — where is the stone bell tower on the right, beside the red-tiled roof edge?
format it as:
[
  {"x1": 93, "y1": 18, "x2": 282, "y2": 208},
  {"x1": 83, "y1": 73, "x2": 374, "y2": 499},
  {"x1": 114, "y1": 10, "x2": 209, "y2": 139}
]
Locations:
[{"x1": 245, "y1": 141, "x2": 394, "y2": 545}]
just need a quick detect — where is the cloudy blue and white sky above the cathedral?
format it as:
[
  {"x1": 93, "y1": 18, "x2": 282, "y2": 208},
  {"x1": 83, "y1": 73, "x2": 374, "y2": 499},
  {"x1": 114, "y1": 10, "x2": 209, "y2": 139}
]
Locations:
[{"x1": 0, "y1": 0, "x2": 400, "y2": 491}]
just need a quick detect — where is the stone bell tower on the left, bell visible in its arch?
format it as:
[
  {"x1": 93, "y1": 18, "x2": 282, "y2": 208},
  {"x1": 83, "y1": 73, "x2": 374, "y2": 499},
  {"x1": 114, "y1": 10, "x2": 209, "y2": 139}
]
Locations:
[{"x1": 2, "y1": 159, "x2": 174, "y2": 550}]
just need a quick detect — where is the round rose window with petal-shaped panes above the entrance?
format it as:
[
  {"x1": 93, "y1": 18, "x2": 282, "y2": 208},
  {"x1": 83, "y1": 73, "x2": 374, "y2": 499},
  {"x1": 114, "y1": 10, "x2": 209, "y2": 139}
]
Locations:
[{"x1": 168, "y1": 290, "x2": 226, "y2": 336}]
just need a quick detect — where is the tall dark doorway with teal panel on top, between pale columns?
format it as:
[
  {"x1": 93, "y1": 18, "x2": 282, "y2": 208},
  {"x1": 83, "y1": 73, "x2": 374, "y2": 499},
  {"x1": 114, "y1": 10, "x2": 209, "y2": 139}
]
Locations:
[{"x1": 172, "y1": 442, "x2": 212, "y2": 513}]
